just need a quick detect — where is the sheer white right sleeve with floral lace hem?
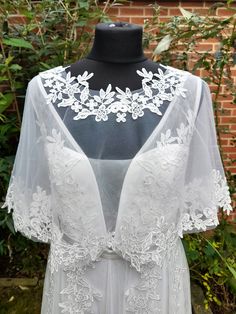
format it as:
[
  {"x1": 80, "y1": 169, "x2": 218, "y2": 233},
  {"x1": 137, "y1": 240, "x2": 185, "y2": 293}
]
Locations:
[{"x1": 179, "y1": 79, "x2": 232, "y2": 237}]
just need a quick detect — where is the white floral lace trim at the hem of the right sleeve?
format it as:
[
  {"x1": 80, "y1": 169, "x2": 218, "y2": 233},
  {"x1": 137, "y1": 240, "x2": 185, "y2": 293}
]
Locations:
[{"x1": 179, "y1": 169, "x2": 233, "y2": 237}]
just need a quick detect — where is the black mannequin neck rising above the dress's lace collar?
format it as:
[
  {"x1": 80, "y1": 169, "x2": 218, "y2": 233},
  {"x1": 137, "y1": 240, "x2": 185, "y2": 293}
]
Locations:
[{"x1": 86, "y1": 22, "x2": 147, "y2": 63}]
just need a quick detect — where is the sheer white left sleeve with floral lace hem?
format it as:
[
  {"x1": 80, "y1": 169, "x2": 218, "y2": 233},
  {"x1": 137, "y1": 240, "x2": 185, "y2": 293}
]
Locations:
[{"x1": 2, "y1": 79, "x2": 51, "y2": 243}]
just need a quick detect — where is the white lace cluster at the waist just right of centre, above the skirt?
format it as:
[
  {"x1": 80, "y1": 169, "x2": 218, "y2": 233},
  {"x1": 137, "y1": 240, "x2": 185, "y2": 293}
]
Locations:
[{"x1": 114, "y1": 216, "x2": 177, "y2": 271}]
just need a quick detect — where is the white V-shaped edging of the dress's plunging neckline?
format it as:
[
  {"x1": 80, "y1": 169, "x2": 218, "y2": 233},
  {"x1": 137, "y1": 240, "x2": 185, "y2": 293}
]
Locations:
[{"x1": 37, "y1": 66, "x2": 191, "y2": 234}]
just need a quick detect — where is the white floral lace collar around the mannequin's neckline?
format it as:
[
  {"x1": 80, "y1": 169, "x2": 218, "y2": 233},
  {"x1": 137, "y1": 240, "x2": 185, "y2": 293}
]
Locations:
[{"x1": 39, "y1": 66, "x2": 187, "y2": 122}]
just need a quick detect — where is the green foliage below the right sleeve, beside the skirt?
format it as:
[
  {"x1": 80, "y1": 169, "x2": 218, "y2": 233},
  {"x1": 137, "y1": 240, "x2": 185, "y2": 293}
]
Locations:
[{"x1": 183, "y1": 221, "x2": 236, "y2": 313}]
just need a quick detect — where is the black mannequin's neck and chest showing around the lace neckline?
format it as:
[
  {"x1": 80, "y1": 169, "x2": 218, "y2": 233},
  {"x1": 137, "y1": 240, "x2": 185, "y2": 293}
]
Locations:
[{"x1": 56, "y1": 22, "x2": 168, "y2": 159}]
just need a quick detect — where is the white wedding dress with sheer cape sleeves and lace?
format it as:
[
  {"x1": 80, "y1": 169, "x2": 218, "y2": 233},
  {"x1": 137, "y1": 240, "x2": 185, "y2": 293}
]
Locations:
[{"x1": 2, "y1": 65, "x2": 232, "y2": 314}]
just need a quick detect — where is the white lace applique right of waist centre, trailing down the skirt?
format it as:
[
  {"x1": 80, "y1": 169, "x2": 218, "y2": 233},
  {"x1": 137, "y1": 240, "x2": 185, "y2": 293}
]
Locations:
[{"x1": 117, "y1": 216, "x2": 178, "y2": 314}]
